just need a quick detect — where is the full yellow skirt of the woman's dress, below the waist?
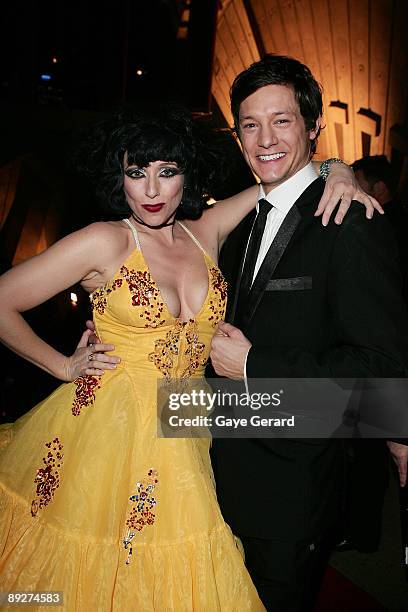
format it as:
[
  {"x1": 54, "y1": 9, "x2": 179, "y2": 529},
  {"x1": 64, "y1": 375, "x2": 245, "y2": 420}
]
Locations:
[{"x1": 0, "y1": 371, "x2": 264, "y2": 612}]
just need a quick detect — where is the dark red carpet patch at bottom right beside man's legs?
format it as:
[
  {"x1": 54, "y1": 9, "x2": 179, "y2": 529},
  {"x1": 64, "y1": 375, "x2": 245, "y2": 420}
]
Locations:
[{"x1": 315, "y1": 566, "x2": 387, "y2": 612}]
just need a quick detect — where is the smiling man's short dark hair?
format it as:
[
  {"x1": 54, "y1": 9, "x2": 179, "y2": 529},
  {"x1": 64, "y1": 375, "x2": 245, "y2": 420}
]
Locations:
[{"x1": 230, "y1": 53, "x2": 323, "y2": 153}]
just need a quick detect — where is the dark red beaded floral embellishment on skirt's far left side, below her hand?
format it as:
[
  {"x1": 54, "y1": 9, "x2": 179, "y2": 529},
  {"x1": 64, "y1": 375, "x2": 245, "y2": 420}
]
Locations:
[{"x1": 31, "y1": 438, "x2": 63, "y2": 516}]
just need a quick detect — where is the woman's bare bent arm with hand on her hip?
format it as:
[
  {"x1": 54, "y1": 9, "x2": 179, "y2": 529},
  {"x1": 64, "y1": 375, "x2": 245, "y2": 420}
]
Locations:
[{"x1": 0, "y1": 223, "x2": 117, "y2": 381}]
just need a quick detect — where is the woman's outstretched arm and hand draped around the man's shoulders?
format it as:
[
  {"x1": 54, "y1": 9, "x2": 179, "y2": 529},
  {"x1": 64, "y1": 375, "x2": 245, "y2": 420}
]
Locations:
[{"x1": 198, "y1": 163, "x2": 384, "y2": 250}]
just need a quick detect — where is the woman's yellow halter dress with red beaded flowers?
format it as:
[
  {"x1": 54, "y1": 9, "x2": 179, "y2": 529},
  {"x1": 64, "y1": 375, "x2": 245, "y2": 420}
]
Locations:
[{"x1": 0, "y1": 221, "x2": 264, "y2": 612}]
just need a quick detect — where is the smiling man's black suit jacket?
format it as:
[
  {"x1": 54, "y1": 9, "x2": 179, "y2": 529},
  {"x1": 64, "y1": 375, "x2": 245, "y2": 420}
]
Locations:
[{"x1": 212, "y1": 179, "x2": 408, "y2": 541}]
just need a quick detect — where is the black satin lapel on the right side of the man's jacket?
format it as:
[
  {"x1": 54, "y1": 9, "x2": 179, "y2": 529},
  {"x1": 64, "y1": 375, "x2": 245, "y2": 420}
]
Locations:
[{"x1": 244, "y1": 178, "x2": 324, "y2": 325}]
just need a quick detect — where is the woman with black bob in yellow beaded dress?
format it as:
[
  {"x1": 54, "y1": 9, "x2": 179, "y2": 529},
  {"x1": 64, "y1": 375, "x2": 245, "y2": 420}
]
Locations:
[{"x1": 0, "y1": 108, "x2": 376, "y2": 612}]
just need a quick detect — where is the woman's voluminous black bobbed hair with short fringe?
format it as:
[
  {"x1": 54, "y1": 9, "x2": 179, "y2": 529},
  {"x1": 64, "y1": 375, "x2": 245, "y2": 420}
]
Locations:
[{"x1": 80, "y1": 104, "x2": 223, "y2": 219}]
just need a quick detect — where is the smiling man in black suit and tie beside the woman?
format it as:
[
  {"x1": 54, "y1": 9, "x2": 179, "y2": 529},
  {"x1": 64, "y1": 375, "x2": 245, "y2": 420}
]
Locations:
[{"x1": 211, "y1": 55, "x2": 408, "y2": 612}]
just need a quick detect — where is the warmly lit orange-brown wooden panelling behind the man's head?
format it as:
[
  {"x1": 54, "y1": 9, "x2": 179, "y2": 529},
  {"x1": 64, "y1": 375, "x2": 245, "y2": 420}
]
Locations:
[{"x1": 213, "y1": 0, "x2": 408, "y2": 167}]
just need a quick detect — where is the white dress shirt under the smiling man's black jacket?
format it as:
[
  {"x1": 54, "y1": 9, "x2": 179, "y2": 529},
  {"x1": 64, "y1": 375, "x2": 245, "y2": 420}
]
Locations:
[{"x1": 244, "y1": 162, "x2": 319, "y2": 393}]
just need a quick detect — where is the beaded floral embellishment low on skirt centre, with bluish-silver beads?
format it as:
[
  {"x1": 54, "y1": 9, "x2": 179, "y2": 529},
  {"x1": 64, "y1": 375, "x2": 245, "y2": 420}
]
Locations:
[{"x1": 123, "y1": 468, "x2": 158, "y2": 565}]
